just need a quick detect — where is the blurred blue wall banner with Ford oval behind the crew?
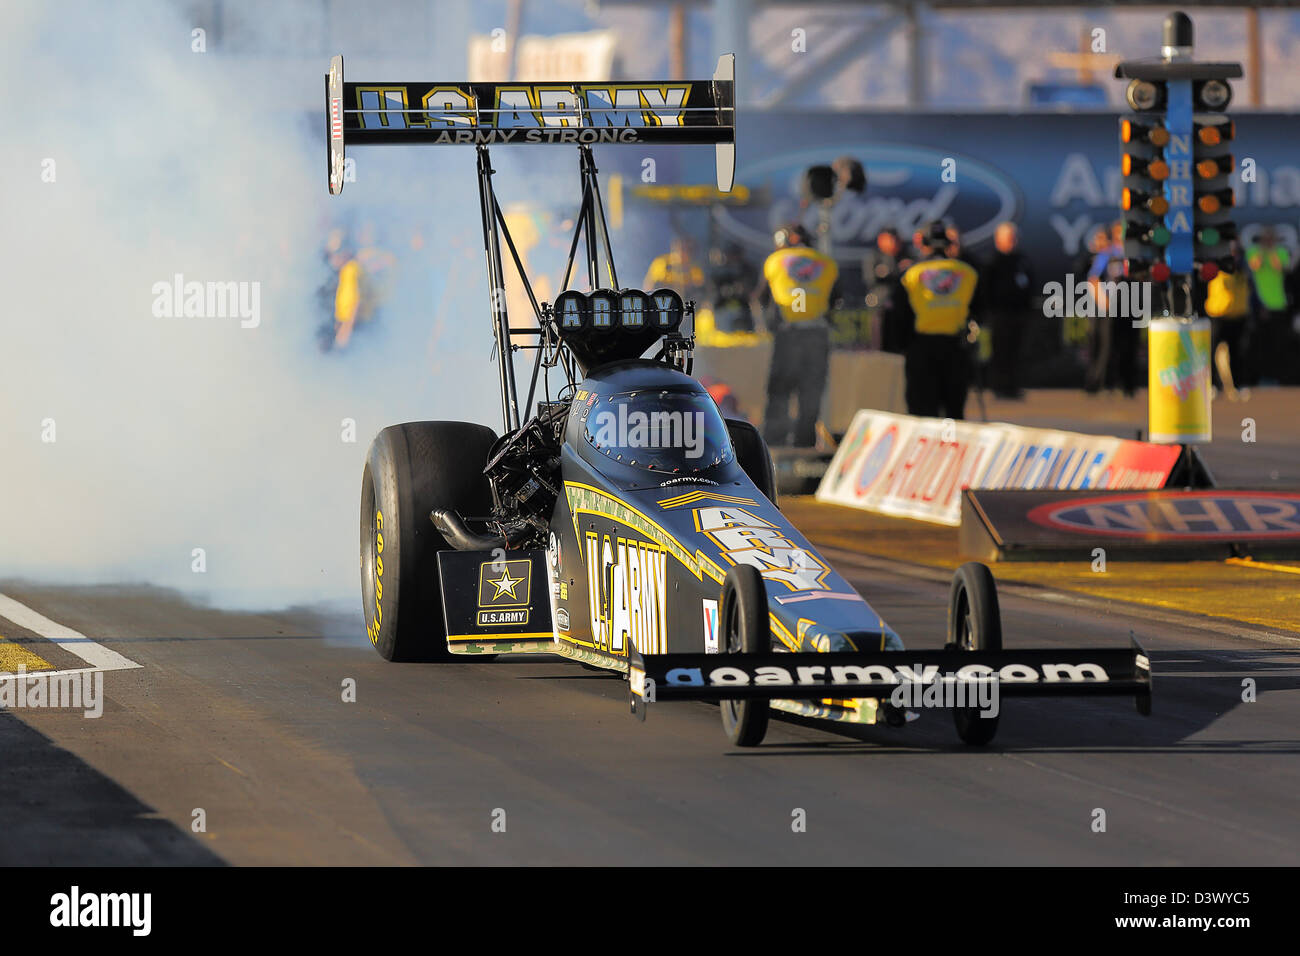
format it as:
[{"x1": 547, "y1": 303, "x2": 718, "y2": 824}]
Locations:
[{"x1": 616, "y1": 111, "x2": 1300, "y2": 280}]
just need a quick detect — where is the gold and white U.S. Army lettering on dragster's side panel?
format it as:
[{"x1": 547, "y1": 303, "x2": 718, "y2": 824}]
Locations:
[{"x1": 586, "y1": 531, "x2": 668, "y2": 654}]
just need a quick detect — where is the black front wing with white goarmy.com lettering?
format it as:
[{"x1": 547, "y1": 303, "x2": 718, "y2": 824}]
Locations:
[{"x1": 628, "y1": 641, "x2": 1151, "y2": 719}]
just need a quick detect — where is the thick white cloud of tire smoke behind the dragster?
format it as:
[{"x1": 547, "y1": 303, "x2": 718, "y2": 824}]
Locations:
[{"x1": 0, "y1": 0, "x2": 517, "y2": 606}]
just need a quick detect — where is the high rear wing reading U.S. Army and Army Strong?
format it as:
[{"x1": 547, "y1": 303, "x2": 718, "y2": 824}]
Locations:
[{"x1": 325, "y1": 53, "x2": 736, "y2": 195}]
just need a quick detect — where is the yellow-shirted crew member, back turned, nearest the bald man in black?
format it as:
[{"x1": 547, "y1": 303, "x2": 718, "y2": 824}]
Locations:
[{"x1": 902, "y1": 222, "x2": 979, "y2": 420}]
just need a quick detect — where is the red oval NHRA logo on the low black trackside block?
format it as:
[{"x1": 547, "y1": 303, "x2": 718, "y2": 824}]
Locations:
[{"x1": 1027, "y1": 492, "x2": 1300, "y2": 541}]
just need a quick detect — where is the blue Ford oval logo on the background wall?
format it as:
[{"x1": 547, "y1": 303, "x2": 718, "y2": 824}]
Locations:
[{"x1": 715, "y1": 143, "x2": 1022, "y2": 260}]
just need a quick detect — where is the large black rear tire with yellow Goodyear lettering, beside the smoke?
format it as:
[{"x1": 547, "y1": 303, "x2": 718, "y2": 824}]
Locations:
[{"x1": 361, "y1": 421, "x2": 497, "y2": 661}]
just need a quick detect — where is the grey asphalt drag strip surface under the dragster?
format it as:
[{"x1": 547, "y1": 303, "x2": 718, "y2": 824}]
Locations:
[{"x1": 0, "y1": 551, "x2": 1300, "y2": 866}]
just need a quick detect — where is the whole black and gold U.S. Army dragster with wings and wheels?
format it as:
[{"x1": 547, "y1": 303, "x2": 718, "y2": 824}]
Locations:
[{"x1": 340, "y1": 56, "x2": 1149, "y2": 745}]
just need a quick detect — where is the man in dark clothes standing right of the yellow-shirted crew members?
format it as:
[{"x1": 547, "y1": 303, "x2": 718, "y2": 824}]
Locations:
[{"x1": 979, "y1": 222, "x2": 1034, "y2": 398}]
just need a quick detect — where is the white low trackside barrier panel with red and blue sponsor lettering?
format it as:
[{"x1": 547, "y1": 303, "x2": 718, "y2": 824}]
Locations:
[{"x1": 816, "y1": 410, "x2": 1179, "y2": 527}]
